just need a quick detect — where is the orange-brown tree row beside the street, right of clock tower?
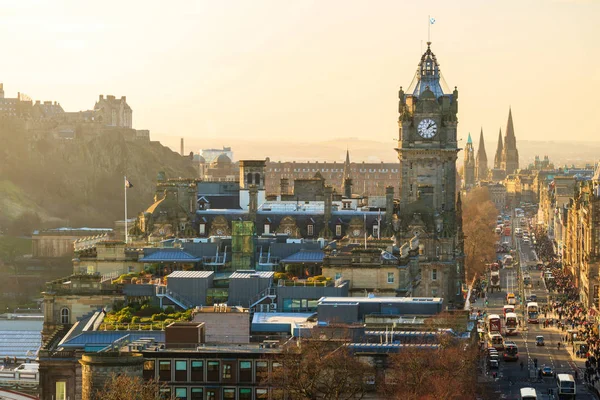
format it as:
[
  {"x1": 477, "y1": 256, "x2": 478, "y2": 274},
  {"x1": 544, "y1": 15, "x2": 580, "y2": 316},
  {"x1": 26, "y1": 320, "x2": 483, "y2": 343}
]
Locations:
[{"x1": 463, "y1": 187, "x2": 498, "y2": 280}]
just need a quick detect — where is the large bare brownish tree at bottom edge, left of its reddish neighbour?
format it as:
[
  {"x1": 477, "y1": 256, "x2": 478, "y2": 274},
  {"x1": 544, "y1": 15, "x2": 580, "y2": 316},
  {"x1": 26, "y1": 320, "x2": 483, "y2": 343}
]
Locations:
[{"x1": 263, "y1": 334, "x2": 375, "y2": 400}]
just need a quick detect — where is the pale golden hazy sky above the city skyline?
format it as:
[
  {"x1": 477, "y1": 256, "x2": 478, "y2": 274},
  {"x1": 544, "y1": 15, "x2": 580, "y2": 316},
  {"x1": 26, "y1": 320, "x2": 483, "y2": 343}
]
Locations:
[{"x1": 0, "y1": 0, "x2": 600, "y2": 158}]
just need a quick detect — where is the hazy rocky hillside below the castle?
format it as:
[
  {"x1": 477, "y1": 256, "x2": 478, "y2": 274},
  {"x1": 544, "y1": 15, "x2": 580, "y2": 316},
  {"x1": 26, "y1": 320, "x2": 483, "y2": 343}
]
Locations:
[{"x1": 0, "y1": 121, "x2": 195, "y2": 227}]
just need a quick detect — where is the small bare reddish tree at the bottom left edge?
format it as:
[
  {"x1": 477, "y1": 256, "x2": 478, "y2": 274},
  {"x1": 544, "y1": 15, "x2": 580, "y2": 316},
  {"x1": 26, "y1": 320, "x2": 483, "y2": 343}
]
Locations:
[{"x1": 94, "y1": 374, "x2": 166, "y2": 400}]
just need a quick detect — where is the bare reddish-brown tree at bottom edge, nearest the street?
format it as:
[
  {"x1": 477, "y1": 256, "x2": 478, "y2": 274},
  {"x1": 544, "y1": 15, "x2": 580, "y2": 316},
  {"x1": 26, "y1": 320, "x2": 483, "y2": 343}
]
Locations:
[{"x1": 380, "y1": 340, "x2": 479, "y2": 400}]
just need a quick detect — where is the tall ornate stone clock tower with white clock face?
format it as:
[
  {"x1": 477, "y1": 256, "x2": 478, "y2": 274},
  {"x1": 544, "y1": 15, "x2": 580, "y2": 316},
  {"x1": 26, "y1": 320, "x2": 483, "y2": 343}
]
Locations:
[{"x1": 396, "y1": 42, "x2": 464, "y2": 305}]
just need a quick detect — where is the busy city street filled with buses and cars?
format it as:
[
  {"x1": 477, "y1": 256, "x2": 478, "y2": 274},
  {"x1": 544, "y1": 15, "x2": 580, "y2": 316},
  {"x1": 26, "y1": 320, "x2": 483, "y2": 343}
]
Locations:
[{"x1": 487, "y1": 216, "x2": 597, "y2": 400}]
